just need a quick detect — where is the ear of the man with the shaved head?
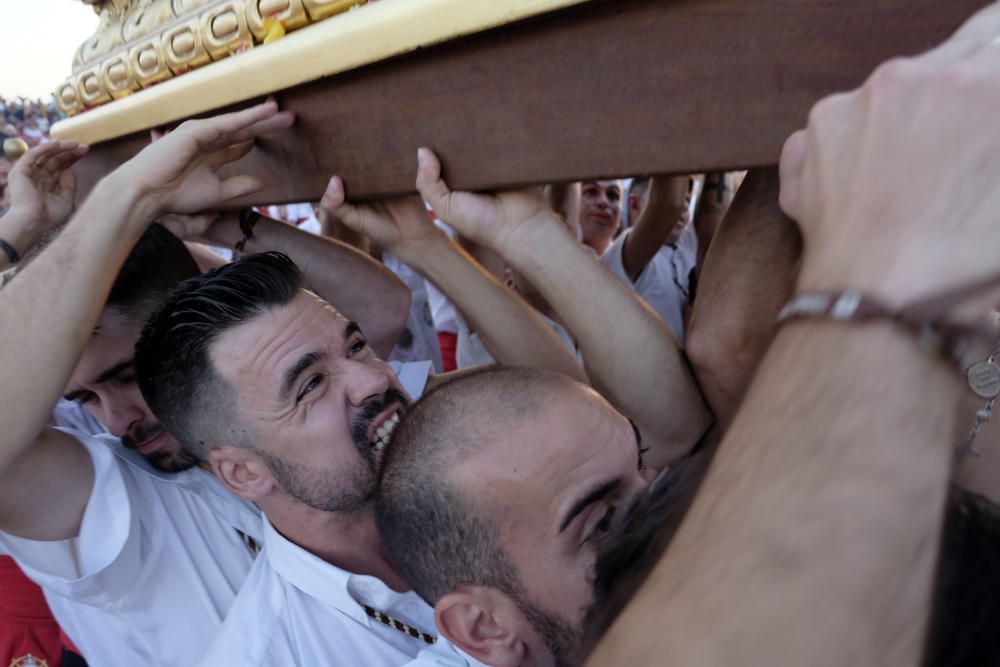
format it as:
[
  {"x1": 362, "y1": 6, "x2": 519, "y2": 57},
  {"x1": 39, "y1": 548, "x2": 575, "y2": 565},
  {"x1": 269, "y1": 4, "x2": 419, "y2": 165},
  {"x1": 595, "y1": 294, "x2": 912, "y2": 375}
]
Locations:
[{"x1": 434, "y1": 586, "x2": 527, "y2": 667}]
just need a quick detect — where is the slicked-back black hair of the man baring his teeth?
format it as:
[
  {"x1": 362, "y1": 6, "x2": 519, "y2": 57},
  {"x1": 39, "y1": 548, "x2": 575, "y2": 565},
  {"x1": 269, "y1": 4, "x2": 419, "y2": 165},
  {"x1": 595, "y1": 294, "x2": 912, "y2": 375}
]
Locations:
[{"x1": 135, "y1": 252, "x2": 302, "y2": 460}]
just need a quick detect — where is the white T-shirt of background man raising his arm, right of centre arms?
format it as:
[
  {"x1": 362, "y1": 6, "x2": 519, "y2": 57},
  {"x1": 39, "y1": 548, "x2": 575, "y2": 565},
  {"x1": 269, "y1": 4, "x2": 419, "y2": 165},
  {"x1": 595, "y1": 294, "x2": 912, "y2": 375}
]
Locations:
[{"x1": 601, "y1": 230, "x2": 687, "y2": 343}]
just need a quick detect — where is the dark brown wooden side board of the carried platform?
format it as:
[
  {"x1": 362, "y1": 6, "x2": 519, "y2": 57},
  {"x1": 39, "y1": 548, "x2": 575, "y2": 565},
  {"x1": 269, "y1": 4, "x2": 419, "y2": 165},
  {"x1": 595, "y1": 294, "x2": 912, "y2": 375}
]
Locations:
[{"x1": 68, "y1": 0, "x2": 987, "y2": 204}]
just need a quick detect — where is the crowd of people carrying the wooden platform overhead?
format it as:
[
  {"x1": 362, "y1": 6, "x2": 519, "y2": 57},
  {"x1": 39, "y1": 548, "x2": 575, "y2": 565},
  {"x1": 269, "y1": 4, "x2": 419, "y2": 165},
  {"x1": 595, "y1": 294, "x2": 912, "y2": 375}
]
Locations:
[{"x1": 0, "y1": 4, "x2": 1000, "y2": 667}]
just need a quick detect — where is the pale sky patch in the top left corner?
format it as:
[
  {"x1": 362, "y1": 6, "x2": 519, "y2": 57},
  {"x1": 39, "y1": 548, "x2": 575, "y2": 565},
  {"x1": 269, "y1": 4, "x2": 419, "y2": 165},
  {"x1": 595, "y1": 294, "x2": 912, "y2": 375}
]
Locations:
[{"x1": 0, "y1": 0, "x2": 97, "y2": 98}]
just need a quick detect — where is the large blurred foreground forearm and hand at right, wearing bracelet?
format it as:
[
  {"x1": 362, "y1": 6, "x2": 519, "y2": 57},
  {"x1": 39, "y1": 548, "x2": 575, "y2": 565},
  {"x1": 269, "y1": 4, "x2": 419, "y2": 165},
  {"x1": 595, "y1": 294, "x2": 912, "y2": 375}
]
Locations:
[{"x1": 592, "y1": 4, "x2": 1000, "y2": 667}]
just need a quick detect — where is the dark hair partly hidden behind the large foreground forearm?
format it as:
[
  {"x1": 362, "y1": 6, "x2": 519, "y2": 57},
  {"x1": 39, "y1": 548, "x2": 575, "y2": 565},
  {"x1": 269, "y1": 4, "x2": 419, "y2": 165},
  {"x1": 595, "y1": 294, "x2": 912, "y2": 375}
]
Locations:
[{"x1": 585, "y1": 472, "x2": 1000, "y2": 667}]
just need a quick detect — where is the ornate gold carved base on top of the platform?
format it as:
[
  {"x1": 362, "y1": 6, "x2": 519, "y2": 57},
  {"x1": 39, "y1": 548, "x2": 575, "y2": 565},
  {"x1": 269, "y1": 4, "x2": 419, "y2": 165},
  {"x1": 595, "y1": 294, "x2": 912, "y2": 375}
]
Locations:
[{"x1": 55, "y1": 0, "x2": 368, "y2": 115}]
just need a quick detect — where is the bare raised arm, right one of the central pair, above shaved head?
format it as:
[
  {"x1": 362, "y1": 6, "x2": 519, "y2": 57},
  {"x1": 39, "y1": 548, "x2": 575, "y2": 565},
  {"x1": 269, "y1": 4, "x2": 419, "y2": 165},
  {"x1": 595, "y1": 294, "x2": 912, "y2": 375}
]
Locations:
[{"x1": 417, "y1": 149, "x2": 710, "y2": 466}]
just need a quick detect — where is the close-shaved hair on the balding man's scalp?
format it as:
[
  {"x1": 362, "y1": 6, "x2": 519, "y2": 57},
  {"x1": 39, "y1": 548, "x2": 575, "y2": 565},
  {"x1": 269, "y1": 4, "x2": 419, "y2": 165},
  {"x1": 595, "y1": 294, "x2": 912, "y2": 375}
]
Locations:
[{"x1": 375, "y1": 366, "x2": 572, "y2": 606}]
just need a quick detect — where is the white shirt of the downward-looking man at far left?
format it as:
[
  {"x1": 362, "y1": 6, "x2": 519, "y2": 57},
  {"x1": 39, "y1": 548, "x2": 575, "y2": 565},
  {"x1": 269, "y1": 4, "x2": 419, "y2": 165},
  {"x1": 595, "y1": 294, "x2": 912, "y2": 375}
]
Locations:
[{"x1": 0, "y1": 430, "x2": 262, "y2": 667}]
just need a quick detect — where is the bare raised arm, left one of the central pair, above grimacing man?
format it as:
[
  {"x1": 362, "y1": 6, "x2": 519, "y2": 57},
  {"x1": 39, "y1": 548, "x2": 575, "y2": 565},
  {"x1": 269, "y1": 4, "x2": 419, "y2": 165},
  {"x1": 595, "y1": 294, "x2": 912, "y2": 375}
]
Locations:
[{"x1": 320, "y1": 177, "x2": 586, "y2": 382}]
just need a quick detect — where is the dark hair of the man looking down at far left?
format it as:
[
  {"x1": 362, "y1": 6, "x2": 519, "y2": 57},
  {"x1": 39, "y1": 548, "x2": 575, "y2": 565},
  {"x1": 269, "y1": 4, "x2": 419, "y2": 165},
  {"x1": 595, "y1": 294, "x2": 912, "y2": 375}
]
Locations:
[{"x1": 107, "y1": 224, "x2": 201, "y2": 321}]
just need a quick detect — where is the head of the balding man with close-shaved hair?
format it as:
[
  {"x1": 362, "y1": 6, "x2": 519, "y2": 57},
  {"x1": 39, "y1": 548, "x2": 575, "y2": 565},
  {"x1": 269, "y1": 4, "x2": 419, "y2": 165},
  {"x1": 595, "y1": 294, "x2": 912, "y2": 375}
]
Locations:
[{"x1": 377, "y1": 368, "x2": 652, "y2": 665}]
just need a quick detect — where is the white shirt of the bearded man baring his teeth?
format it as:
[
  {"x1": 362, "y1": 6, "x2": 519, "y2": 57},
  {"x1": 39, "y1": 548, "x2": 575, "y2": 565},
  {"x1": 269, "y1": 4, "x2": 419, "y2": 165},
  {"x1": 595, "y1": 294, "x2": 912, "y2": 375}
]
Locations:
[{"x1": 199, "y1": 522, "x2": 437, "y2": 667}]
